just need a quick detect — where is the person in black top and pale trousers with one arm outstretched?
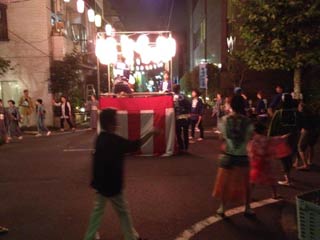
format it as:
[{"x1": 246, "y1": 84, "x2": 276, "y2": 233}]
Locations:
[{"x1": 84, "y1": 108, "x2": 157, "y2": 240}]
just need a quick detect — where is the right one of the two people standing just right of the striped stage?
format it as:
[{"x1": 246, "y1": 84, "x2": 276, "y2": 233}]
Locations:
[{"x1": 190, "y1": 89, "x2": 204, "y2": 143}]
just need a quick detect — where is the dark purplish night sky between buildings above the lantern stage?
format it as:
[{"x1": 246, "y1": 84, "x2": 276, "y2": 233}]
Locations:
[{"x1": 109, "y1": 0, "x2": 188, "y2": 32}]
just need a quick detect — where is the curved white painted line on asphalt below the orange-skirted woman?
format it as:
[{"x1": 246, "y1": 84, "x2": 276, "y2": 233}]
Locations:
[{"x1": 175, "y1": 198, "x2": 280, "y2": 240}]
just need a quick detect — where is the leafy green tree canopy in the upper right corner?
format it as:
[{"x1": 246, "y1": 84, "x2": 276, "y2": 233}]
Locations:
[{"x1": 236, "y1": 0, "x2": 320, "y2": 71}]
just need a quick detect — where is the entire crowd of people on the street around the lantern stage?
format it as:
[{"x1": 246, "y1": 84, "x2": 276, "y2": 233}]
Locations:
[{"x1": 0, "y1": 85, "x2": 319, "y2": 240}]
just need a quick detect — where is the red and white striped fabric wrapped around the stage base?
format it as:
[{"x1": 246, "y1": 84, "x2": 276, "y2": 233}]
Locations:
[{"x1": 100, "y1": 96, "x2": 175, "y2": 156}]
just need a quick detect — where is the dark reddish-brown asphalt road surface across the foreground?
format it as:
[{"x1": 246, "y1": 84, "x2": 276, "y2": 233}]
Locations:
[{"x1": 0, "y1": 131, "x2": 320, "y2": 240}]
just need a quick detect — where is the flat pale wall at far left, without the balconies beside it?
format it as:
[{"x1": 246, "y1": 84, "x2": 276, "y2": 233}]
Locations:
[{"x1": 0, "y1": 0, "x2": 52, "y2": 124}]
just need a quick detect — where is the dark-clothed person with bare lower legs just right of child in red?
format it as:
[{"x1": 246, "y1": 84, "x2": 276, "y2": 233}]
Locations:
[{"x1": 268, "y1": 94, "x2": 300, "y2": 186}]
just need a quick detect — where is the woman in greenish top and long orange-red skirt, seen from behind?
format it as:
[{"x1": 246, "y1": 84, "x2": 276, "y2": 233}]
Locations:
[{"x1": 213, "y1": 95, "x2": 254, "y2": 217}]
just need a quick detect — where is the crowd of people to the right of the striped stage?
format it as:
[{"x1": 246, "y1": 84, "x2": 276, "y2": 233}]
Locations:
[{"x1": 174, "y1": 85, "x2": 320, "y2": 216}]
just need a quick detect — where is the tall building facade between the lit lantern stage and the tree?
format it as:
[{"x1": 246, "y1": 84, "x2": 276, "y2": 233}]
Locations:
[{"x1": 189, "y1": 0, "x2": 234, "y2": 69}]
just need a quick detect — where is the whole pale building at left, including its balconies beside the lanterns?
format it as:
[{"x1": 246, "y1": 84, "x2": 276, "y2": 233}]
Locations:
[{"x1": 0, "y1": 0, "x2": 104, "y2": 124}]
